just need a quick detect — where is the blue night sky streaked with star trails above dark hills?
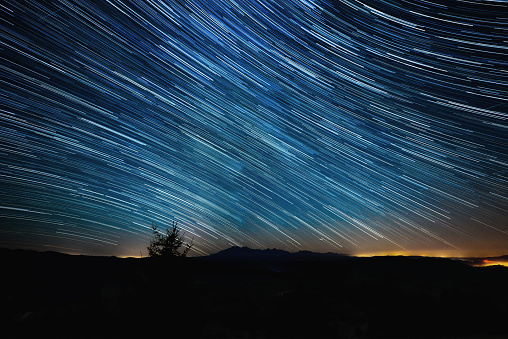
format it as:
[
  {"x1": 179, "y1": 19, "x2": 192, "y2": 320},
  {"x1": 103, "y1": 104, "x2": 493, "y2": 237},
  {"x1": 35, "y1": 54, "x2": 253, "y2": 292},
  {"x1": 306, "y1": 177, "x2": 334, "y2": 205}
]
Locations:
[{"x1": 0, "y1": 0, "x2": 508, "y2": 256}]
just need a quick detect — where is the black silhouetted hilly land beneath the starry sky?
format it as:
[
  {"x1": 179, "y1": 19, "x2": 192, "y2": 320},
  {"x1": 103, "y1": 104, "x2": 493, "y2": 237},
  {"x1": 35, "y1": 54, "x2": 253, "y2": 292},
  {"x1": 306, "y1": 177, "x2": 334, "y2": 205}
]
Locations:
[{"x1": 0, "y1": 248, "x2": 508, "y2": 338}]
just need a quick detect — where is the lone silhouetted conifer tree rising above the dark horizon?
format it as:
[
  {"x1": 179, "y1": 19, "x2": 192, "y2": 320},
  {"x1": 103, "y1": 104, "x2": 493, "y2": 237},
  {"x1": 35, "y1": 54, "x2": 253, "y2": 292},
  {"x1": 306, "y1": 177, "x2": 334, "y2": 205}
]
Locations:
[{"x1": 147, "y1": 221, "x2": 193, "y2": 257}]
